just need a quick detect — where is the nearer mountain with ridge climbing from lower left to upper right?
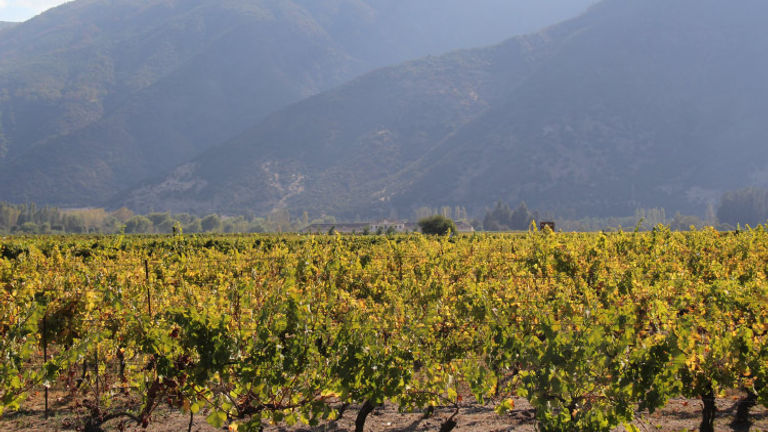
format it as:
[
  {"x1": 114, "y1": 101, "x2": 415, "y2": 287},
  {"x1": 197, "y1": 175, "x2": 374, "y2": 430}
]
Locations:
[{"x1": 121, "y1": 0, "x2": 768, "y2": 218}]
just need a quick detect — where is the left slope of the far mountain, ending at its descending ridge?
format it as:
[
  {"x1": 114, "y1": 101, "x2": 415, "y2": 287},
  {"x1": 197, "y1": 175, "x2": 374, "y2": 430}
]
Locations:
[{"x1": 0, "y1": 0, "x2": 356, "y2": 205}]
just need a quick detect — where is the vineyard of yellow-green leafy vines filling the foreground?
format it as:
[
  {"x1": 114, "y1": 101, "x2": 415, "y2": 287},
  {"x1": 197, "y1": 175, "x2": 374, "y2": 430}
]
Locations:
[{"x1": 0, "y1": 226, "x2": 768, "y2": 432}]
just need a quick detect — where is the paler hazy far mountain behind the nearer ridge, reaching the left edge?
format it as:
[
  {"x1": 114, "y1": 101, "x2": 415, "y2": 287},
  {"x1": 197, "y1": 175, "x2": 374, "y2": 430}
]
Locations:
[{"x1": 0, "y1": 0, "x2": 591, "y2": 206}]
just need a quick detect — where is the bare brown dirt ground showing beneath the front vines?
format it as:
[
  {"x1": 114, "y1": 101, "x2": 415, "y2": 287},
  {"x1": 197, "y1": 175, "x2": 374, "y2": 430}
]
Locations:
[{"x1": 0, "y1": 399, "x2": 768, "y2": 432}]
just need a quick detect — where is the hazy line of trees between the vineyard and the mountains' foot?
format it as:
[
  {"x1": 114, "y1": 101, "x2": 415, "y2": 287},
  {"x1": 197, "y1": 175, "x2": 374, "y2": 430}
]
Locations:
[{"x1": 0, "y1": 188, "x2": 768, "y2": 235}]
